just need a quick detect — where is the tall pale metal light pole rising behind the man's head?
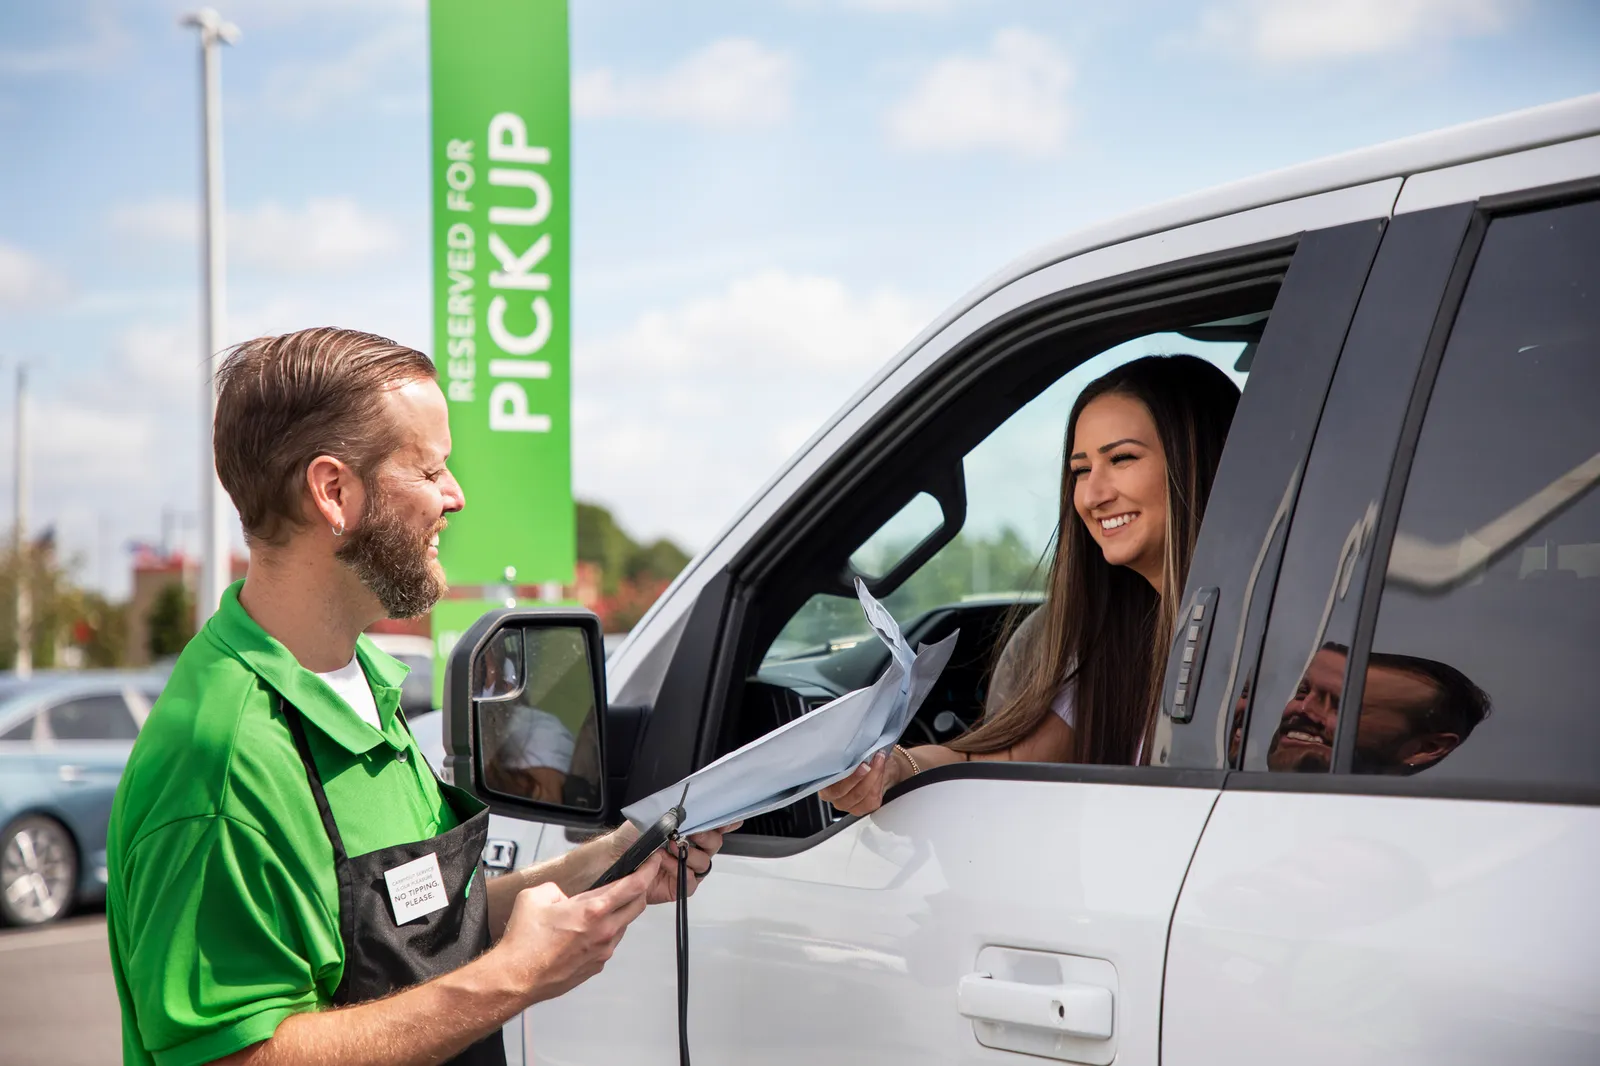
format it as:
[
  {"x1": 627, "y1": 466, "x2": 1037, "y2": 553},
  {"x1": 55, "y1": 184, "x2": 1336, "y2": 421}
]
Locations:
[{"x1": 182, "y1": 8, "x2": 238, "y2": 627}]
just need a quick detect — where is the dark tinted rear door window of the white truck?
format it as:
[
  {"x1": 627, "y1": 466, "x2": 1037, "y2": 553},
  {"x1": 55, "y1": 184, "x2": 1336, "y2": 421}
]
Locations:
[{"x1": 1350, "y1": 202, "x2": 1600, "y2": 786}]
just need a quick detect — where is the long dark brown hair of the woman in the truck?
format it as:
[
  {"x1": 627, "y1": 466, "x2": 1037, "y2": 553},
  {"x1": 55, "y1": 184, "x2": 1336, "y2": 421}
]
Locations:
[{"x1": 950, "y1": 355, "x2": 1238, "y2": 765}]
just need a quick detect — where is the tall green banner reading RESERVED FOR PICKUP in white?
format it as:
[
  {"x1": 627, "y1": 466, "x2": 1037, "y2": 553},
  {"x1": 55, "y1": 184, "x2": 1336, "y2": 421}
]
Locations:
[{"x1": 429, "y1": 0, "x2": 576, "y2": 599}]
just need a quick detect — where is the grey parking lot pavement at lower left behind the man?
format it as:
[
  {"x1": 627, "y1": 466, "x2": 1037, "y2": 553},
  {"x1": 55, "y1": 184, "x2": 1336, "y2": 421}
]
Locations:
[{"x1": 0, "y1": 914, "x2": 122, "y2": 1066}]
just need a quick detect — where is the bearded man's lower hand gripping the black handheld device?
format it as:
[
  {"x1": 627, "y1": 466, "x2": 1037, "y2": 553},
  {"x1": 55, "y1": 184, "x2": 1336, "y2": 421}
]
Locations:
[{"x1": 494, "y1": 855, "x2": 666, "y2": 1004}]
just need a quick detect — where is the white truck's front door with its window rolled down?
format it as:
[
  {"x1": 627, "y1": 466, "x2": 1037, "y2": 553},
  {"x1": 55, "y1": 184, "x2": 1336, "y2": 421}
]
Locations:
[{"x1": 526, "y1": 181, "x2": 1398, "y2": 1066}]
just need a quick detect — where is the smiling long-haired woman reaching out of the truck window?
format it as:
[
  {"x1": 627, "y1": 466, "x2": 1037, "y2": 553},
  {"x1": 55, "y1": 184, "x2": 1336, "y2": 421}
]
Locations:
[{"x1": 821, "y1": 355, "x2": 1238, "y2": 813}]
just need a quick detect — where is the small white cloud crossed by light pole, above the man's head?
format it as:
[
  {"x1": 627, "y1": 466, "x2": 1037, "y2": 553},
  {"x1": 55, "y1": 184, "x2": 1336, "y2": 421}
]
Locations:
[{"x1": 110, "y1": 197, "x2": 403, "y2": 274}]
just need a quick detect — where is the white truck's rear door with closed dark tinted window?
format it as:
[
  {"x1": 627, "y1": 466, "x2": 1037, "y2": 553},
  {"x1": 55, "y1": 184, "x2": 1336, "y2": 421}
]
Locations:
[{"x1": 1162, "y1": 156, "x2": 1600, "y2": 1066}]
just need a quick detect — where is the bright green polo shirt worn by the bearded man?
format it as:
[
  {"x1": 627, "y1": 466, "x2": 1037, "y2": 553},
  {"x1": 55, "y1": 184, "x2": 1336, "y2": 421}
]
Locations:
[{"x1": 106, "y1": 584, "x2": 458, "y2": 1066}]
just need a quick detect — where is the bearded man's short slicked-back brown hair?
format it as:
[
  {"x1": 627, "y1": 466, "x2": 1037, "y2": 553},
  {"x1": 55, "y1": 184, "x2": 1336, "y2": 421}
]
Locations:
[{"x1": 211, "y1": 327, "x2": 434, "y2": 546}]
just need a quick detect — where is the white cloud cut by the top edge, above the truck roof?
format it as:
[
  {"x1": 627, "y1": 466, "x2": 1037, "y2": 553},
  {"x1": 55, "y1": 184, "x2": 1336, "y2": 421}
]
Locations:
[{"x1": 1198, "y1": 0, "x2": 1510, "y2": 64}]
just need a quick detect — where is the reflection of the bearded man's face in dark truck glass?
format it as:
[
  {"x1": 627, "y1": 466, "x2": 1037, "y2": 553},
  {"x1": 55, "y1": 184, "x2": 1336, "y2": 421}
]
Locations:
[{"x1": 1267, "y1": 643, "x2": 1490, "y2": 775}]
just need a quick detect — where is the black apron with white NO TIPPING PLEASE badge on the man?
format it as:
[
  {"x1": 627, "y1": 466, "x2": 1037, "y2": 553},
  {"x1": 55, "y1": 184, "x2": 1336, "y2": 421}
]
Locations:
[{"x1": 282, "y1": 701, "x2": 506, "y2": 1066}]
